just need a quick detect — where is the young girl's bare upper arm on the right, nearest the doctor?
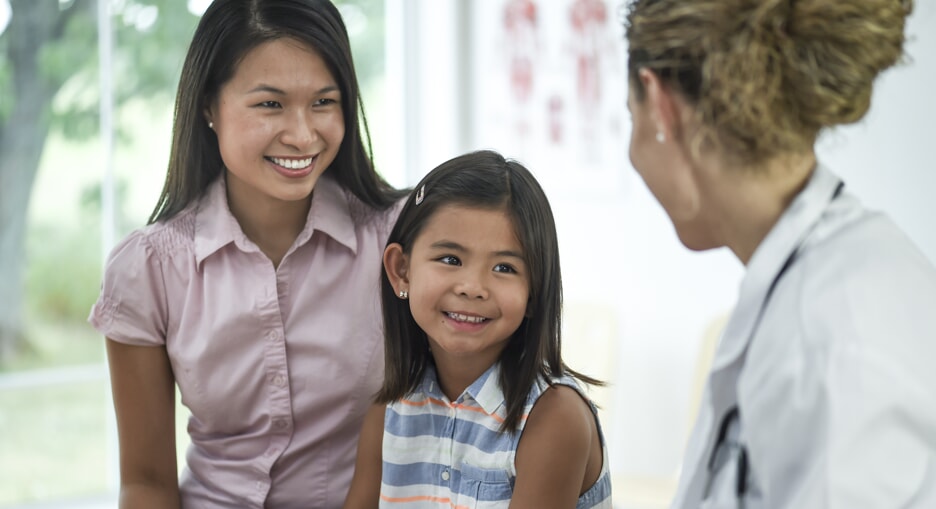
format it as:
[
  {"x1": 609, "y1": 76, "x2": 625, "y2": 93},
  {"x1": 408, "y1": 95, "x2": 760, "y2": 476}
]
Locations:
[{"x1": 510, "y1": 385, "x2": 603, "y2": 509}]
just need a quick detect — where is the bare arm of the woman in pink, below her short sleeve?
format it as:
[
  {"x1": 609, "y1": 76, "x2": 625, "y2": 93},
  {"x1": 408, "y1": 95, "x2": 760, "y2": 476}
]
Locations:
[{"x1": 107, "y1": 339, "x2": 181, "y2": 509}]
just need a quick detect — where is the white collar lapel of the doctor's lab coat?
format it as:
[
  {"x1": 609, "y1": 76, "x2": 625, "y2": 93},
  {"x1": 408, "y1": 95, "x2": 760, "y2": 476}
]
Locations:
[{"x1": 712, "y1": 165, "x2": 841, "y2": 372}]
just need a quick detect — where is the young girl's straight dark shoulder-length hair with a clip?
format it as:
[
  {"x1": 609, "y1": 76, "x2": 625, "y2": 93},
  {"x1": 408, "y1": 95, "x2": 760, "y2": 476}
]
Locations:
[{"x1": 377, "y1": 151, "x2": 601, "y2": 431}]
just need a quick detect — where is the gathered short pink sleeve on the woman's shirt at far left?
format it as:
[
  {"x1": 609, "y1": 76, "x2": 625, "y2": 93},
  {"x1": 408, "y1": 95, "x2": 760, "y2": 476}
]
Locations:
[{"x1": 88, "y1": 231, "x2": 168, "y2": 346}]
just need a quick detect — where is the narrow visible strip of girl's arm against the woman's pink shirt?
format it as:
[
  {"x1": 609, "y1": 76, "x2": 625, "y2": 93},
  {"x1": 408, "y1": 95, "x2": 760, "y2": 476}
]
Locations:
[{"x1": 344, "y1": 404, "x2": 387, "y2": 509}]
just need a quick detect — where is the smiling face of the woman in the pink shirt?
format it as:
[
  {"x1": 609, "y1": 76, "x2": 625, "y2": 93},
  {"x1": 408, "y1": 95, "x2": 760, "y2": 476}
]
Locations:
[{"x1": 207, "y1": 39, "x2": 345, "y2": 208}]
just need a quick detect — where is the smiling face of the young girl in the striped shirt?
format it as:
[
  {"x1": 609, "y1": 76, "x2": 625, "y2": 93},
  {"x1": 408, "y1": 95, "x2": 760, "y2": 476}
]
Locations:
[{"x1": 397, "y1": 205, "x2": 530, "y2": 369}]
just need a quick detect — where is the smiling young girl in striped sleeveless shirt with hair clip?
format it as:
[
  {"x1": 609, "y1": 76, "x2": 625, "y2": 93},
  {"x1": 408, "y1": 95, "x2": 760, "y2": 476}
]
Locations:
[{"x1": 345, "y1": 152, "x2": 611, "y2": 509}]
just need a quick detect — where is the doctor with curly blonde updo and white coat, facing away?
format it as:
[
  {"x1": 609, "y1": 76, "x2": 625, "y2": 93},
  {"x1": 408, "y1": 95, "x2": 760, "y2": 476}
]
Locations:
[{"x1": 626, "y1": 0, "x2": 936, "y2": 509}]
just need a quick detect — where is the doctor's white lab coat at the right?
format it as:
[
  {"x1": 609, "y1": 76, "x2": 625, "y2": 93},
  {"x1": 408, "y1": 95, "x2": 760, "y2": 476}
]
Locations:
[{"x1": 673, "y1": 166, "x2": 936, "y2": 509}]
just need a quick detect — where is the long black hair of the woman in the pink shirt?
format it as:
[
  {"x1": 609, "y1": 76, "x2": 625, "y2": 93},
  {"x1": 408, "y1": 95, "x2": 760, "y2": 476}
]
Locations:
[{"x1": 149, "y1": 0, "x2": 403, "y2": 223}]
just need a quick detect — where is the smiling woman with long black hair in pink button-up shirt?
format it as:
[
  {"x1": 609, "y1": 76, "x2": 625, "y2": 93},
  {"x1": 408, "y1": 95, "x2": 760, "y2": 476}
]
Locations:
[{"x1": 90, "y1": 0, "x2": 404, "y2": 509}]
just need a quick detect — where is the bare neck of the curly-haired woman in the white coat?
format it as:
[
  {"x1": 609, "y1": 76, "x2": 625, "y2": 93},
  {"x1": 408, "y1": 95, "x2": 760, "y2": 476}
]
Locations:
[{"x1": 715, "y1": 151, "x2": 816, "y2": 265}]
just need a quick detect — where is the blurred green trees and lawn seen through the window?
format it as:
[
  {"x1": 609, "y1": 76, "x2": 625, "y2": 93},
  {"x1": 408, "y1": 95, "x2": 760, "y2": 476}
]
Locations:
[{"x1": 0, "y1": 0, "x2": 384, "y2": 508}]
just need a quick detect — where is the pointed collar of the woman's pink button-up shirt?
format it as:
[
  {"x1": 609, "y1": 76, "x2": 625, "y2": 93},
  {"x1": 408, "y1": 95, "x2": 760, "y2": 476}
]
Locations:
[{"x1": 195, "y1": 175, "x2": 357, "y2": 264}]
